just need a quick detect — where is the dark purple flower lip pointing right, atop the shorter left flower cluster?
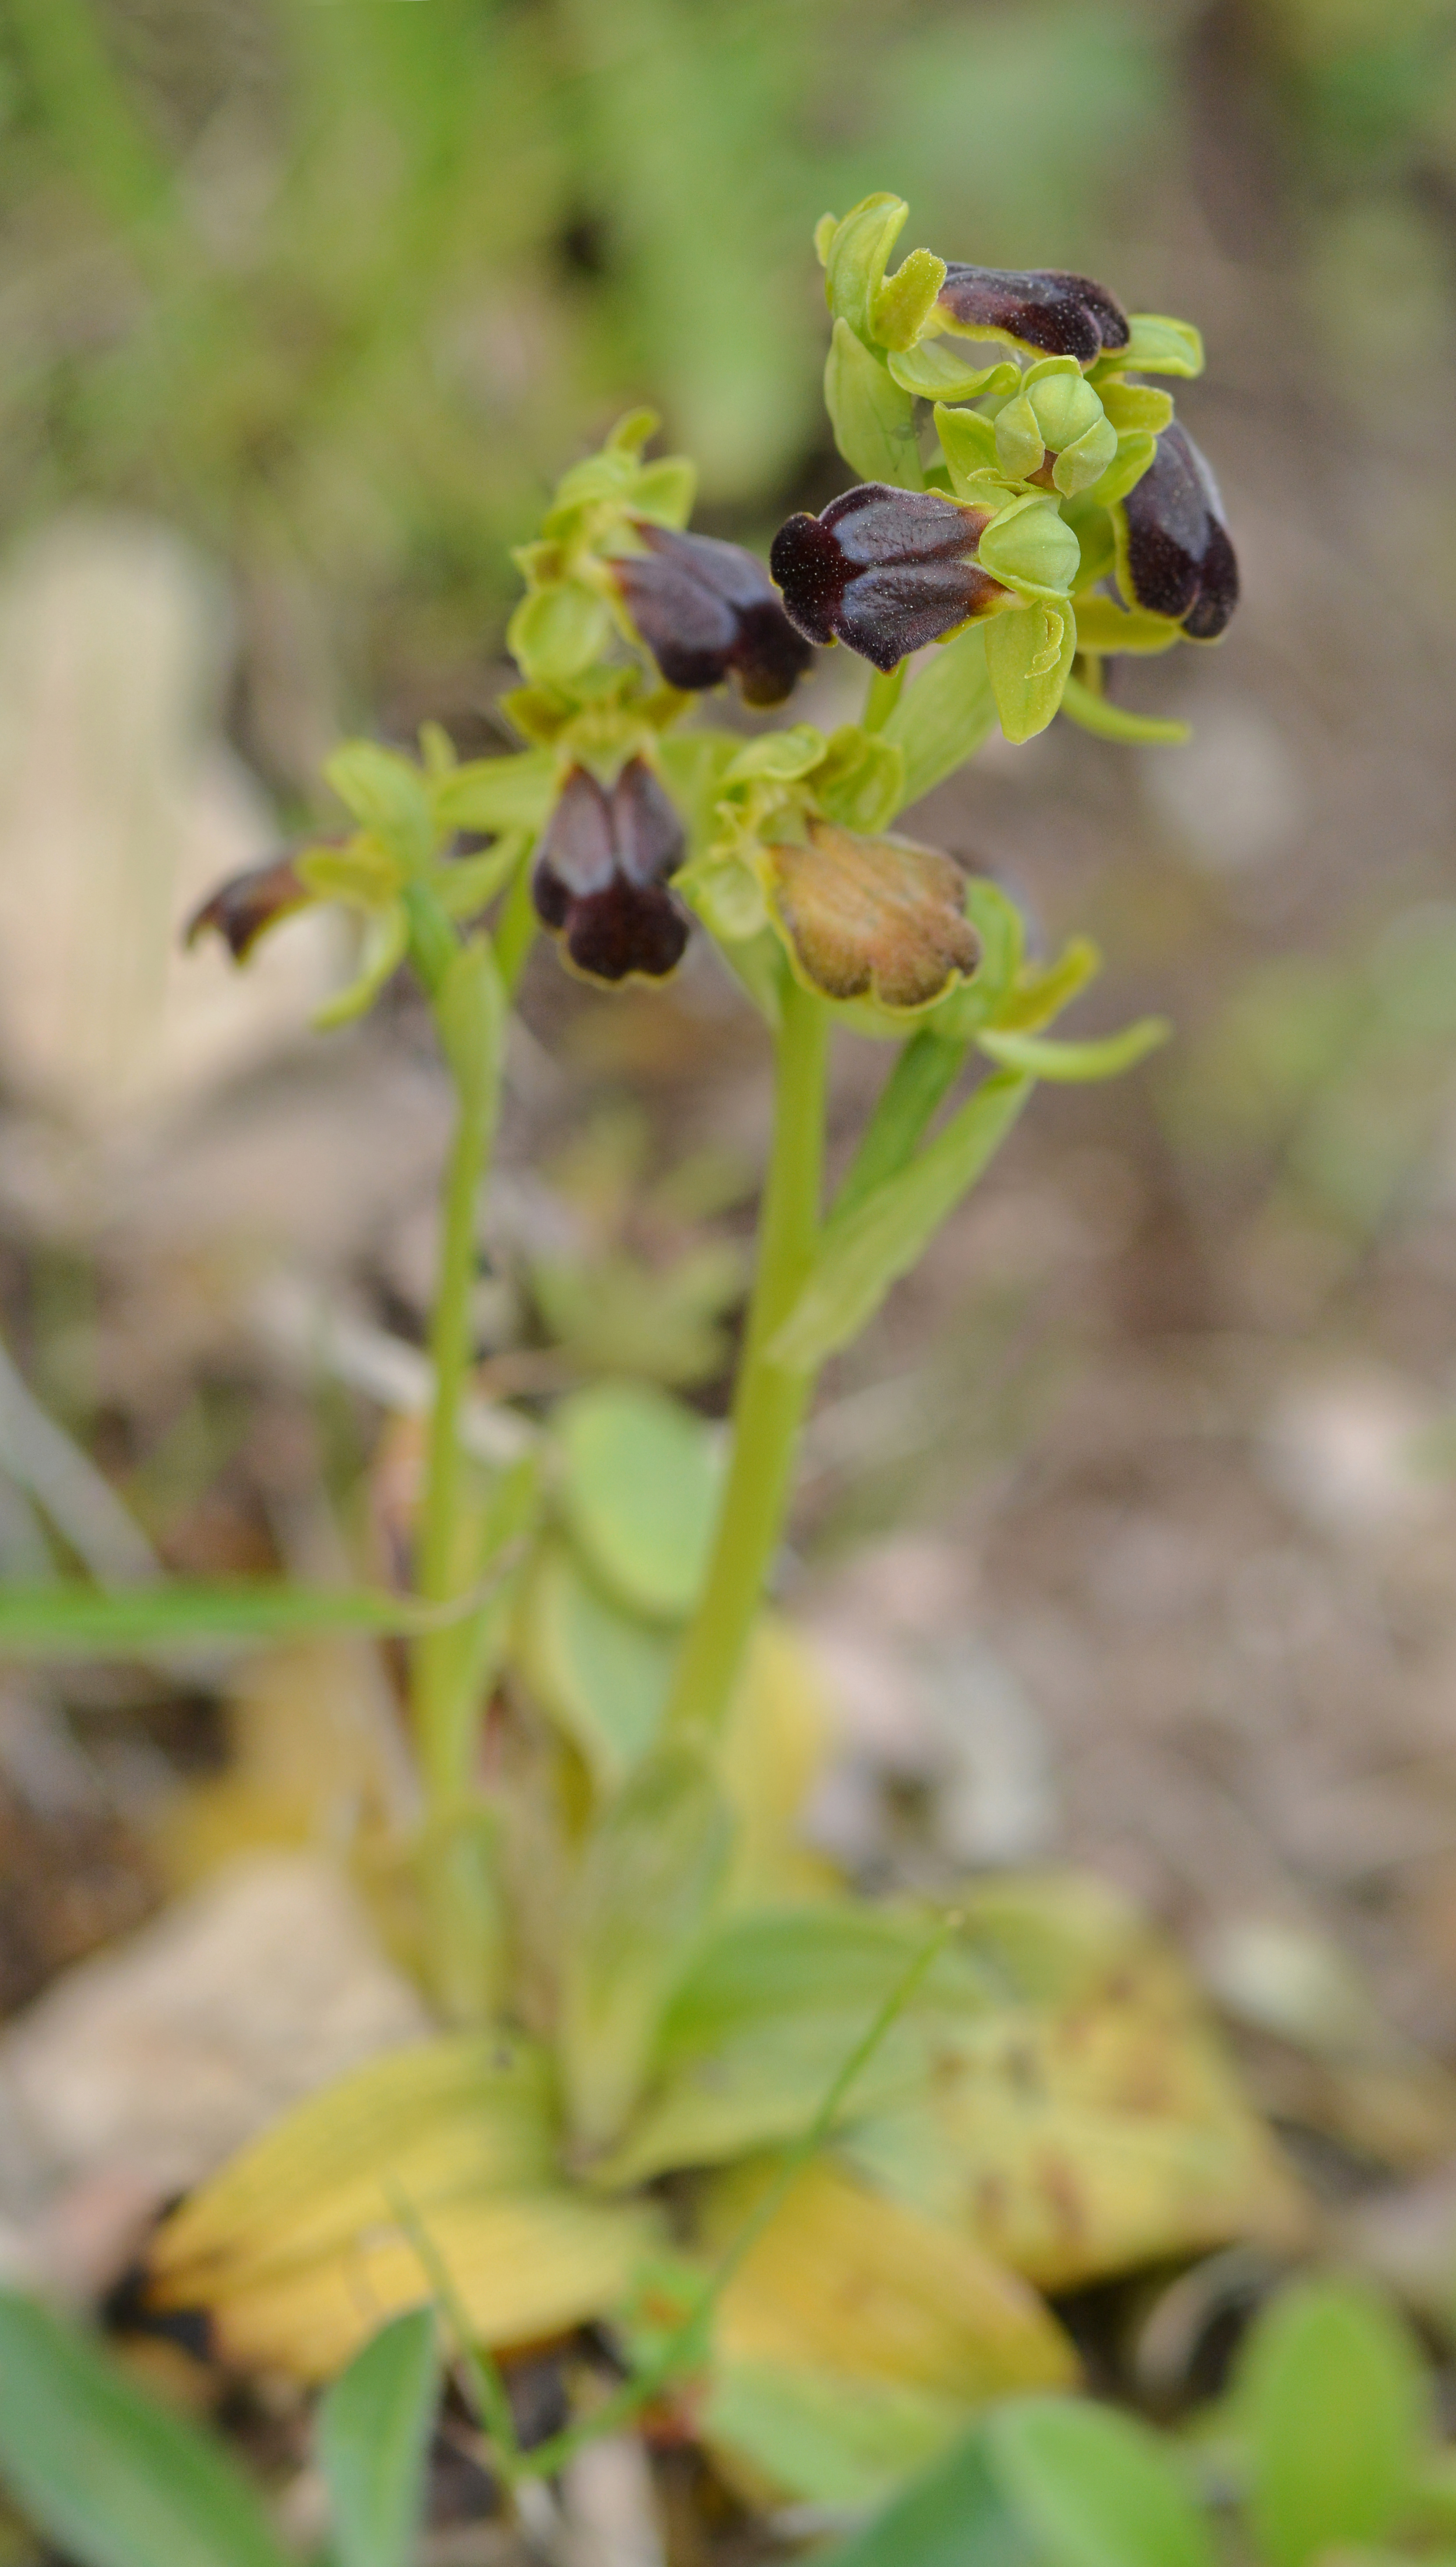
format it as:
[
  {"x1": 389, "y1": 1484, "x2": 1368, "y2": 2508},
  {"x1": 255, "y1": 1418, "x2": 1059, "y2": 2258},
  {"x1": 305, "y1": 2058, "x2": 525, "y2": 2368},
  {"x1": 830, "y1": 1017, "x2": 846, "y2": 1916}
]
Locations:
[{"x1": 611, "y1": 523, "x2": 814, "y2": 703}]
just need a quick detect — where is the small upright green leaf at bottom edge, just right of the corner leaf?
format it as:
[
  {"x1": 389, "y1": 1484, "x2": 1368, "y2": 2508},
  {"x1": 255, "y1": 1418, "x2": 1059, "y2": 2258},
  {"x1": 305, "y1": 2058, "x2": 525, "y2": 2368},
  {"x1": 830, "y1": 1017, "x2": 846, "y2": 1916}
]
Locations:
[{"x1": 319, "y1": 2308, "x2": 439, "y2": 2567}]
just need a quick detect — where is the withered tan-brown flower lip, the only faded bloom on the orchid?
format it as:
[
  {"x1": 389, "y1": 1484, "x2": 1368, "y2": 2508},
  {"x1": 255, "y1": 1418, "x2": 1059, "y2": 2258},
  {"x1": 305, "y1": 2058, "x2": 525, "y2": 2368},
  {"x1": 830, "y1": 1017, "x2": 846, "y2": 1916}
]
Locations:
[{"x1": 765, "y1": 819, "x2": 981, "y2": 1006}]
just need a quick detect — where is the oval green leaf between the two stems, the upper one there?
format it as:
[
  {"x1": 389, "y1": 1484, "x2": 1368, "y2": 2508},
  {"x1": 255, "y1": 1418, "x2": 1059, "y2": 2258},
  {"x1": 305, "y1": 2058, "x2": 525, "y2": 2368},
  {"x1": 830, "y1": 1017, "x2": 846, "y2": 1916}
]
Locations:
[{"x1": 555, "y1": 1381, "x2": 721, "y2": 1622}]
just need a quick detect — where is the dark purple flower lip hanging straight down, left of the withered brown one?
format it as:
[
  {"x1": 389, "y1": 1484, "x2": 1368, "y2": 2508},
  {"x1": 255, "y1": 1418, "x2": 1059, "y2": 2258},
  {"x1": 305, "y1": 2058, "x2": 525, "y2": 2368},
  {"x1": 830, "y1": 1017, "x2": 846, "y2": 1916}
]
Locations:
[{"x1": 532, "y1": 757, "x2": 688, "y2": 981}]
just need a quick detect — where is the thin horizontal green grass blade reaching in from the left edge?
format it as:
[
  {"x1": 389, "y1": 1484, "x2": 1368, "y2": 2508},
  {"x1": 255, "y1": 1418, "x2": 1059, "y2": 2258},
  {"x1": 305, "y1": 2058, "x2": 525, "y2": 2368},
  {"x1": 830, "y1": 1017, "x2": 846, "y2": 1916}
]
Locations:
[{"x1": 0, "y1": 1579, "x2": 465, "y2": 1658}]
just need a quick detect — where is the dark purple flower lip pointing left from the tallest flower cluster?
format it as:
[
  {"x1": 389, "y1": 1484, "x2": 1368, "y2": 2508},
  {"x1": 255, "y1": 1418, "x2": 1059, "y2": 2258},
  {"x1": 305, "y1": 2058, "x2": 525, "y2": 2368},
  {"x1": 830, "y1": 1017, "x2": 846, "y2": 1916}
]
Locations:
[{"x1": 771, "y1": 483, "x2": 1007, "y2": 670}]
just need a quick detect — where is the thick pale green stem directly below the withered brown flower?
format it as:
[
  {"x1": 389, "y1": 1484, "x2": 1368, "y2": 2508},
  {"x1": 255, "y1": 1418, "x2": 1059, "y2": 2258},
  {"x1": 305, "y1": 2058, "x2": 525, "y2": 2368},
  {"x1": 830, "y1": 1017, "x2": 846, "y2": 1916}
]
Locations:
[{"x1": 668, "y1": 973, "x2": 829, "y2": 1735}]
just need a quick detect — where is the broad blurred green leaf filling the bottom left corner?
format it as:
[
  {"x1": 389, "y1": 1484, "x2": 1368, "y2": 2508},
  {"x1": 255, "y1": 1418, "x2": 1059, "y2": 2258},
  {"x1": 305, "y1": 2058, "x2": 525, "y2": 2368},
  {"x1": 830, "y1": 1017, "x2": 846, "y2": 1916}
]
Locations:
[{"x1": 0, "y1": 2290, "x2": 288, "y2": 2567}]
